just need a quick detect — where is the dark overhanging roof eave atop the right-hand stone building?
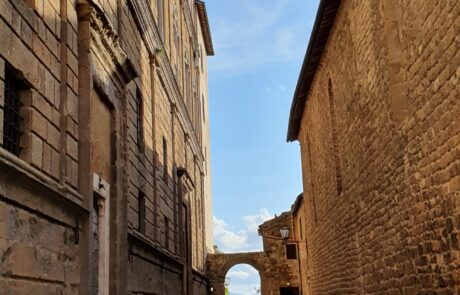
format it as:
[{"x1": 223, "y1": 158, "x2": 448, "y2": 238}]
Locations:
[{"x1": 287, "y1": 0, "x2": 340, "y2": 142}]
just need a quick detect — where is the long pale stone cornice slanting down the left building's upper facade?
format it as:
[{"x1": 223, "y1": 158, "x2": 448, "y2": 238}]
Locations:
[{"x1": 128, "y1": 0, "x2": 204, "y2": 167}]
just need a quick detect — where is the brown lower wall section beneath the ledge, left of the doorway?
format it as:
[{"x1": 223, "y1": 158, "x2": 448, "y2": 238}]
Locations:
[{"x1": 0, "y1": 182, "x2": 80, "y2": 295}]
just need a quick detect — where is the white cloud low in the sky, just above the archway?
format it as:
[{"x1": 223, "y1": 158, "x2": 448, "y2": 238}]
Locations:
[{"x1": 213, "y1": 208, "x2": 273, "y2": 252}]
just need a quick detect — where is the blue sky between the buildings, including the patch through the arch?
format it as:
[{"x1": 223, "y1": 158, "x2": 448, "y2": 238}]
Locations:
[{"x1": 206, "y1": 0, "x2": 318, "y2": 294}]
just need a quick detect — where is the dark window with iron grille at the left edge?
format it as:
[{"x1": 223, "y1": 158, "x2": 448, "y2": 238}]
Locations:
[{"x1": 2, "y1": 64, "x2": 27, "y2": 156}]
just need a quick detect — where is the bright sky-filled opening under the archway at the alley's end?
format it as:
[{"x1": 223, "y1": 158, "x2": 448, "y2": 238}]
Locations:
[{"x1": 224, "y1": 263, "x2": 262, "y2": 295}]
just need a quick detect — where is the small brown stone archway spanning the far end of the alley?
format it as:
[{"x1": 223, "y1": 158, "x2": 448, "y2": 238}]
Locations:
[{"x1": 207, "y1": 252, "x2": 267, "y2": 295}]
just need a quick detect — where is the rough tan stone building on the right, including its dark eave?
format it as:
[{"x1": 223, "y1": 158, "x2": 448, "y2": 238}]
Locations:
[{"x1": 288, "y1": 0, "x2": 460, "y2": 294}]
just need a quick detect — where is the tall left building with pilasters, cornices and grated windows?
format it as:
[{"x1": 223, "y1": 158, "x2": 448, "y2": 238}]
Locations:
[{"x1": 0, "y1": 0, "x2": 213, "y2": 295}]
